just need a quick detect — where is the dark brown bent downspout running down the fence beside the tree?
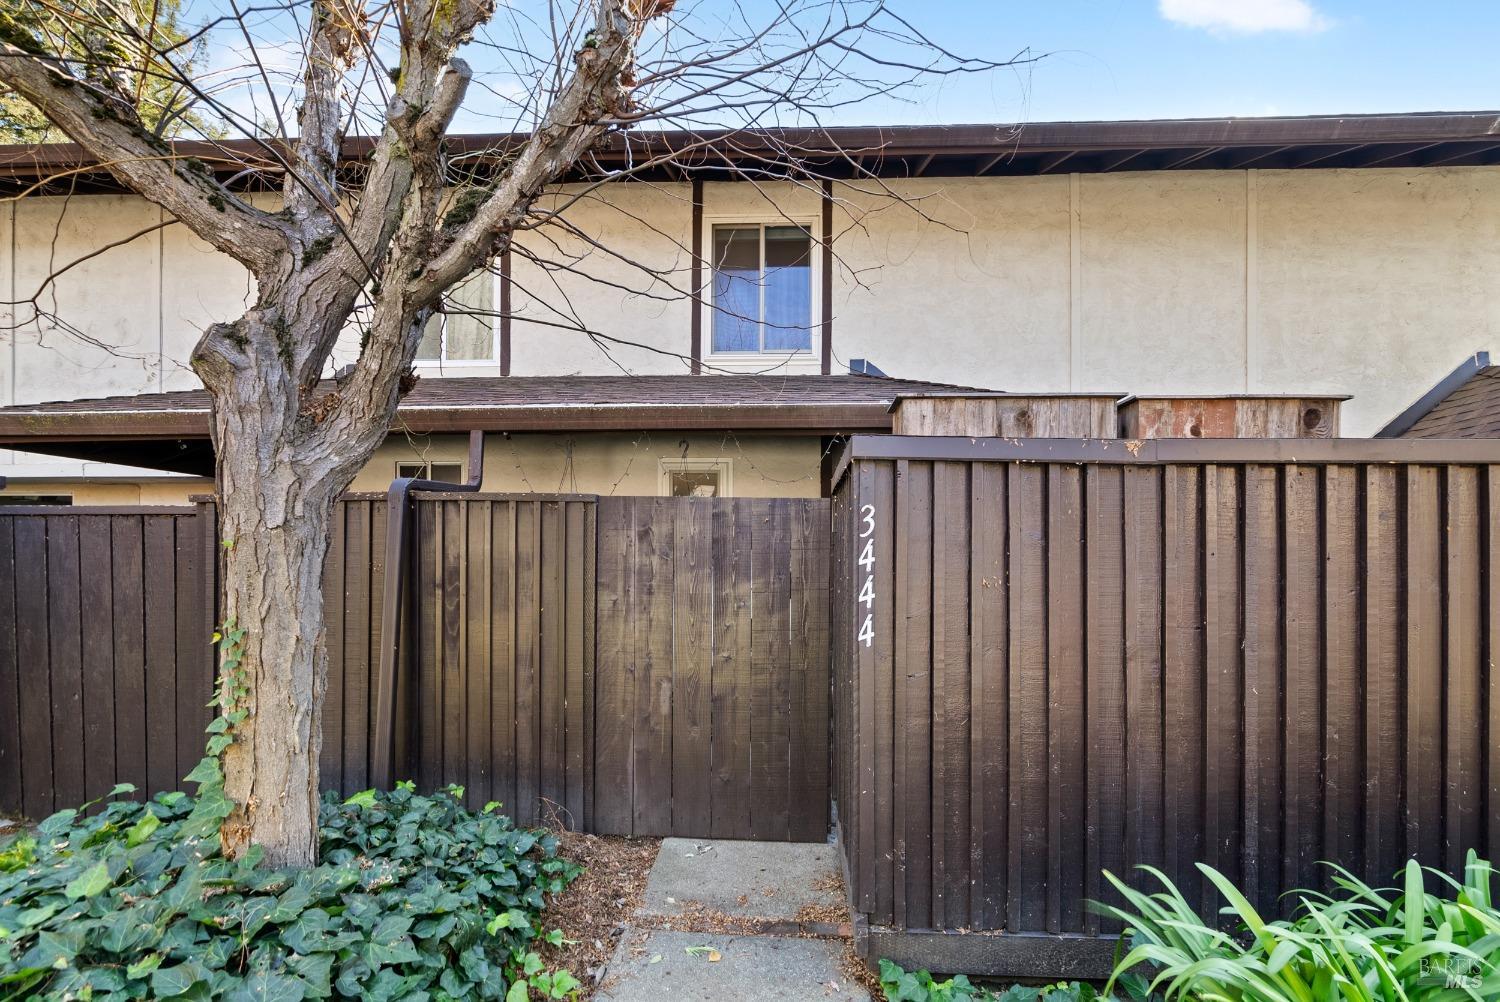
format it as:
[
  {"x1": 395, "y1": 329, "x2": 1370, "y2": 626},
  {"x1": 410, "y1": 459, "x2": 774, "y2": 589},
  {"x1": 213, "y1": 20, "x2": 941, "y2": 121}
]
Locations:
[{"x1": 371, "y1": 431, "x2": 485, "y2": 791}]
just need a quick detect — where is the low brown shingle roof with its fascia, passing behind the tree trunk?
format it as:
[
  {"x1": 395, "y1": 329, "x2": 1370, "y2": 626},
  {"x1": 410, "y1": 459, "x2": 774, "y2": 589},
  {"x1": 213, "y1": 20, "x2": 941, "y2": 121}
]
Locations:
[{"x1": 0, "y1": 375, "x2": 980, "y2": 446}]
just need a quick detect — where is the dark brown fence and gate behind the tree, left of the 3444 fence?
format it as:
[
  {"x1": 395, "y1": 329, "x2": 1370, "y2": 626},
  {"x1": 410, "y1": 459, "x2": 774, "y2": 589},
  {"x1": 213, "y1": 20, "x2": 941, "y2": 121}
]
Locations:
[{"x1": 0, "y1": 495, "x2": 830, "y2": 839}]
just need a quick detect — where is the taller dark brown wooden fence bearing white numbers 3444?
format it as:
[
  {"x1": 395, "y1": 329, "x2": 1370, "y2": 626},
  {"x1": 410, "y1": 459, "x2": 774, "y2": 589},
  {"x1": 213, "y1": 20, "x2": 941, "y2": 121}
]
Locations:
[{"x1": 833, "y1": 438, "x2": 1500, "y2": 974}]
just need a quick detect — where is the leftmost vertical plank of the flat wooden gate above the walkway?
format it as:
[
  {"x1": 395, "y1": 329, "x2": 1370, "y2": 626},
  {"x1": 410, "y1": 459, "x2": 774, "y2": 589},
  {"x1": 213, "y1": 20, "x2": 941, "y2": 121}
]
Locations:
[{"x1": 593, "y1": 498, "x2": 633, "y2": 837}]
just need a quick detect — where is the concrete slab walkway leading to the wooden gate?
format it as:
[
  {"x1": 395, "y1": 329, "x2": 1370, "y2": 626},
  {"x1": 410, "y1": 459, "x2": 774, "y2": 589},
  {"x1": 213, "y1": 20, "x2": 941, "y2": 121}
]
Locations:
[{"x1": 597, "y1": 839, "x2": 870, "y2": 1002}]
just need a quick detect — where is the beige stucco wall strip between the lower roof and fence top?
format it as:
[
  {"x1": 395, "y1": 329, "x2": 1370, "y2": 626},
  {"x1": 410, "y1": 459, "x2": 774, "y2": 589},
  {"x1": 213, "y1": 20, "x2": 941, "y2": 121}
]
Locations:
[{"x1": 351, "y1": 432, "x2": 822, "y2": 498}]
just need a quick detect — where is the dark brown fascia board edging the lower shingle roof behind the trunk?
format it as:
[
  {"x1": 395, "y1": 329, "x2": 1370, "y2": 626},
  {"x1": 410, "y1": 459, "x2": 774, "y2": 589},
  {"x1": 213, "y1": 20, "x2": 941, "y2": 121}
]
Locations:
[{"x1": 0, "y1": 401, "x2": 891, "y2": 438}]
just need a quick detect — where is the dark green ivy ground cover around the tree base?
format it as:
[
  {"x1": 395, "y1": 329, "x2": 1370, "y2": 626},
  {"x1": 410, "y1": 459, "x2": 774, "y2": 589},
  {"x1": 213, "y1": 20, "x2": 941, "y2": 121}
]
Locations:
[{"x1": 0, "y1": 780, "x2": 579, "y2": 1002}]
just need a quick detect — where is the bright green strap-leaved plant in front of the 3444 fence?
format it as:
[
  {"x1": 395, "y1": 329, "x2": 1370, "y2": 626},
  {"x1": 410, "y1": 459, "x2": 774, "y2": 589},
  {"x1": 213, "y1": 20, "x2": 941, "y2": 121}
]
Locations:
[{"x1": 1094, "y1": 852, "x2": 1500, "y2": 1002}]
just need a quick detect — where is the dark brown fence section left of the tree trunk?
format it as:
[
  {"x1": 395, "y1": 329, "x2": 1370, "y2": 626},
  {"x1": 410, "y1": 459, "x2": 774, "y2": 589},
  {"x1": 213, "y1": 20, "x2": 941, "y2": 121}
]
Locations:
[{"x1": 0, "y1": 506, "x2": 215, "y2": 818}]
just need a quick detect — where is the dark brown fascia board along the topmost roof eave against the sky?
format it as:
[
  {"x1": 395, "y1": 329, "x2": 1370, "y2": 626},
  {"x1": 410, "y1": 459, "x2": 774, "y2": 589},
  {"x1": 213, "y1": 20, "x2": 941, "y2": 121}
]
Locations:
[{"x1": 0, "y1": 111, "x2": 1500, "y2": 177}]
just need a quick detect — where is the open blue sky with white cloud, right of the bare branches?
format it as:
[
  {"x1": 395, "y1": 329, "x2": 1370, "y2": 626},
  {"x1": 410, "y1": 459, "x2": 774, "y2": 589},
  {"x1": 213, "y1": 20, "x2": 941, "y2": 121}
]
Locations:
[{"x1": 848, "y1": 0, "x2": 1500, "y2": 123}]
